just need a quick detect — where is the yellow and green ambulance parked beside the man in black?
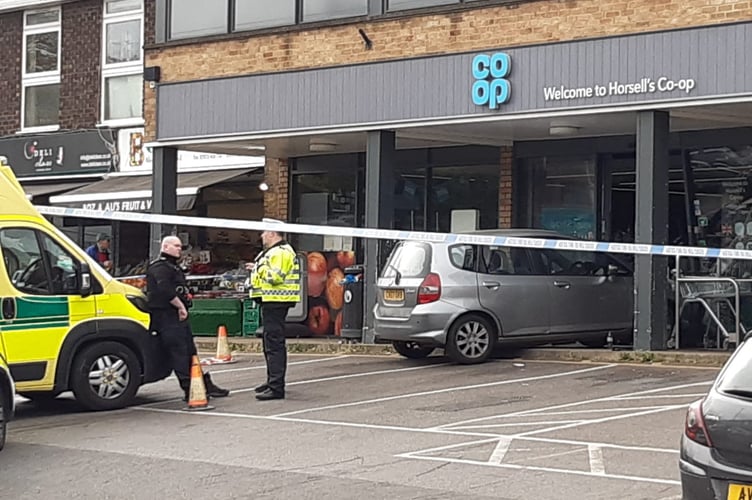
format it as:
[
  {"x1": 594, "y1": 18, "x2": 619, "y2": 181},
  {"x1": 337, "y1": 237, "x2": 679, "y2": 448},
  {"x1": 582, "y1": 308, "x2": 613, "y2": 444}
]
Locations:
[{"x1": 0, "y1": 158, "x2": 169, "y2": 410}]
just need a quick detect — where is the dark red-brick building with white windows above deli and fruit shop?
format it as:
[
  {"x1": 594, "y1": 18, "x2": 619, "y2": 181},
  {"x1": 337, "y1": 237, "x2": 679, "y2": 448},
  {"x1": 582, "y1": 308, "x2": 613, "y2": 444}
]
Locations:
[{"x1": 0, "y1": 0, "x2": 263, "y2": 275}]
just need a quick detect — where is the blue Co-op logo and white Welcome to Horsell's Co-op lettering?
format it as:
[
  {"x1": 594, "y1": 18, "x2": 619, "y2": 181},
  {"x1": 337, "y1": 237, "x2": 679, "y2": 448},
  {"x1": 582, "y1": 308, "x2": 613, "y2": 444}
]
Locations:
[{"x1": 472, "y1": 52, "x2": 697, "y2": 109}]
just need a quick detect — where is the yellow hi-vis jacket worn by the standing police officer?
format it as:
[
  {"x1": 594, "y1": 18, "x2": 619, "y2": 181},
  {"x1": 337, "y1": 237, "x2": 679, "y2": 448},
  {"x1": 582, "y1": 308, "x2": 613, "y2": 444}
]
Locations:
[{"x1": 251, "y1": 241, "x2": 300, "y2": 303}]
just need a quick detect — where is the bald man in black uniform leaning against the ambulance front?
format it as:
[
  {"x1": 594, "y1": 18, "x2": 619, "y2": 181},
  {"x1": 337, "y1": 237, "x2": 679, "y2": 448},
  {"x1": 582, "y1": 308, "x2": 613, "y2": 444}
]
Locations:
[{"x1": 146, "y1": 236, "x2": 230, "y2": 400}]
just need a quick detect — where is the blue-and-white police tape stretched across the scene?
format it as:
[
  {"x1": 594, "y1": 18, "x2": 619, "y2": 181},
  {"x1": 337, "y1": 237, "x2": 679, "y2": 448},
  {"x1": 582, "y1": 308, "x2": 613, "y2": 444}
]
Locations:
[{"x1": 36, "y1": 206, "x2": 752, "y2": 260}]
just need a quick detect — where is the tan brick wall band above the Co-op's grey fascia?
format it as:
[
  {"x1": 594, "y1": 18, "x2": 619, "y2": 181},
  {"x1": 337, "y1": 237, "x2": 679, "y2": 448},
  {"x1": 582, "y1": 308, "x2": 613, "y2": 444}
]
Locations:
[{"x1": 144, "y1": 0, "x2": 752, "y2": 139}]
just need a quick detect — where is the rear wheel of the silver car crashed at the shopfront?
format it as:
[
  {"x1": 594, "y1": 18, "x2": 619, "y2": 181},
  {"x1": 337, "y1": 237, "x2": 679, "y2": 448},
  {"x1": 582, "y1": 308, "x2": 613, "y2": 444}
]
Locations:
[{"x1": 446, "y1": 314, "x2": 496, "y2": 365}]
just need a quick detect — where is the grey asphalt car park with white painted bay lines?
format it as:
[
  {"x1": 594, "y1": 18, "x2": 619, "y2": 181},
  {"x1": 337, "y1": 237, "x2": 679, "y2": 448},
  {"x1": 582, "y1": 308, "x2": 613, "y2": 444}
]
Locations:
[{"x1": 0, "y1": 355, "x2": 716, "y2": 500}]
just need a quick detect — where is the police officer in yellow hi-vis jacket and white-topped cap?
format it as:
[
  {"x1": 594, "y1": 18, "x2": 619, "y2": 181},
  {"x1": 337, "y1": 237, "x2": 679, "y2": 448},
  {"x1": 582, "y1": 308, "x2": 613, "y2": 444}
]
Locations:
[{"x1": 246, "y1": 219, "x2": 300, "y2": 401}]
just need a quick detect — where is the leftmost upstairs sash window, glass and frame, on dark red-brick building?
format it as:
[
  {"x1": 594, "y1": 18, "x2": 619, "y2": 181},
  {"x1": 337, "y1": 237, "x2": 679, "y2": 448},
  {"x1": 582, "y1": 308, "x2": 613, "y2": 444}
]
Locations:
[{"x1": 22, "y1": 8, "x2": 60, "y2": 129}]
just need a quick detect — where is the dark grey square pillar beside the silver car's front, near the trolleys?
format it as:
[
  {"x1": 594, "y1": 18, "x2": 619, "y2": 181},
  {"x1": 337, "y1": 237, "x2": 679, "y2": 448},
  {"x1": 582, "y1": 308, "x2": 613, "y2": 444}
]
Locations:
[{"x1": 634, "y1": 111, "x2": 669, "y2": 350}]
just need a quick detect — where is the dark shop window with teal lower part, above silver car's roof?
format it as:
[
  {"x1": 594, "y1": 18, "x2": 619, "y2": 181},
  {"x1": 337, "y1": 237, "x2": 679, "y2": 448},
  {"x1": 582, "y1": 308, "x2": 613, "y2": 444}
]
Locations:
[{"x1": 520, "y1": 156, "x2": 597, "y2": 240}]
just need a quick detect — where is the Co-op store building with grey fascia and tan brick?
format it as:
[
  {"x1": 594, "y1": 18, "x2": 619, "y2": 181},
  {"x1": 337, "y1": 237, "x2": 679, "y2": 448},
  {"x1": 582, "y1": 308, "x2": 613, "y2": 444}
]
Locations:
[{"x1": 128, "y1": 0, "x2": 752, "y2": 349}]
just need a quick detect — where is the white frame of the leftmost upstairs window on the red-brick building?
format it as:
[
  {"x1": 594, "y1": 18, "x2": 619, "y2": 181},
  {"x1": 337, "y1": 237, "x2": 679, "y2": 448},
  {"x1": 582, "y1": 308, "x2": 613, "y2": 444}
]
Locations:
[{"x1": 20, "y1": 7, "x2": 63, "y2": 133}]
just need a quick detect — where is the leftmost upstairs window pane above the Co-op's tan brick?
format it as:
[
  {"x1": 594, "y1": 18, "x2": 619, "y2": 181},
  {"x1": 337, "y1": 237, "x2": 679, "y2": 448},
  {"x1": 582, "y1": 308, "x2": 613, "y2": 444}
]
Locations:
[{"x1": 170, "y1": 0, "x2": 228, "y2": 39}]
